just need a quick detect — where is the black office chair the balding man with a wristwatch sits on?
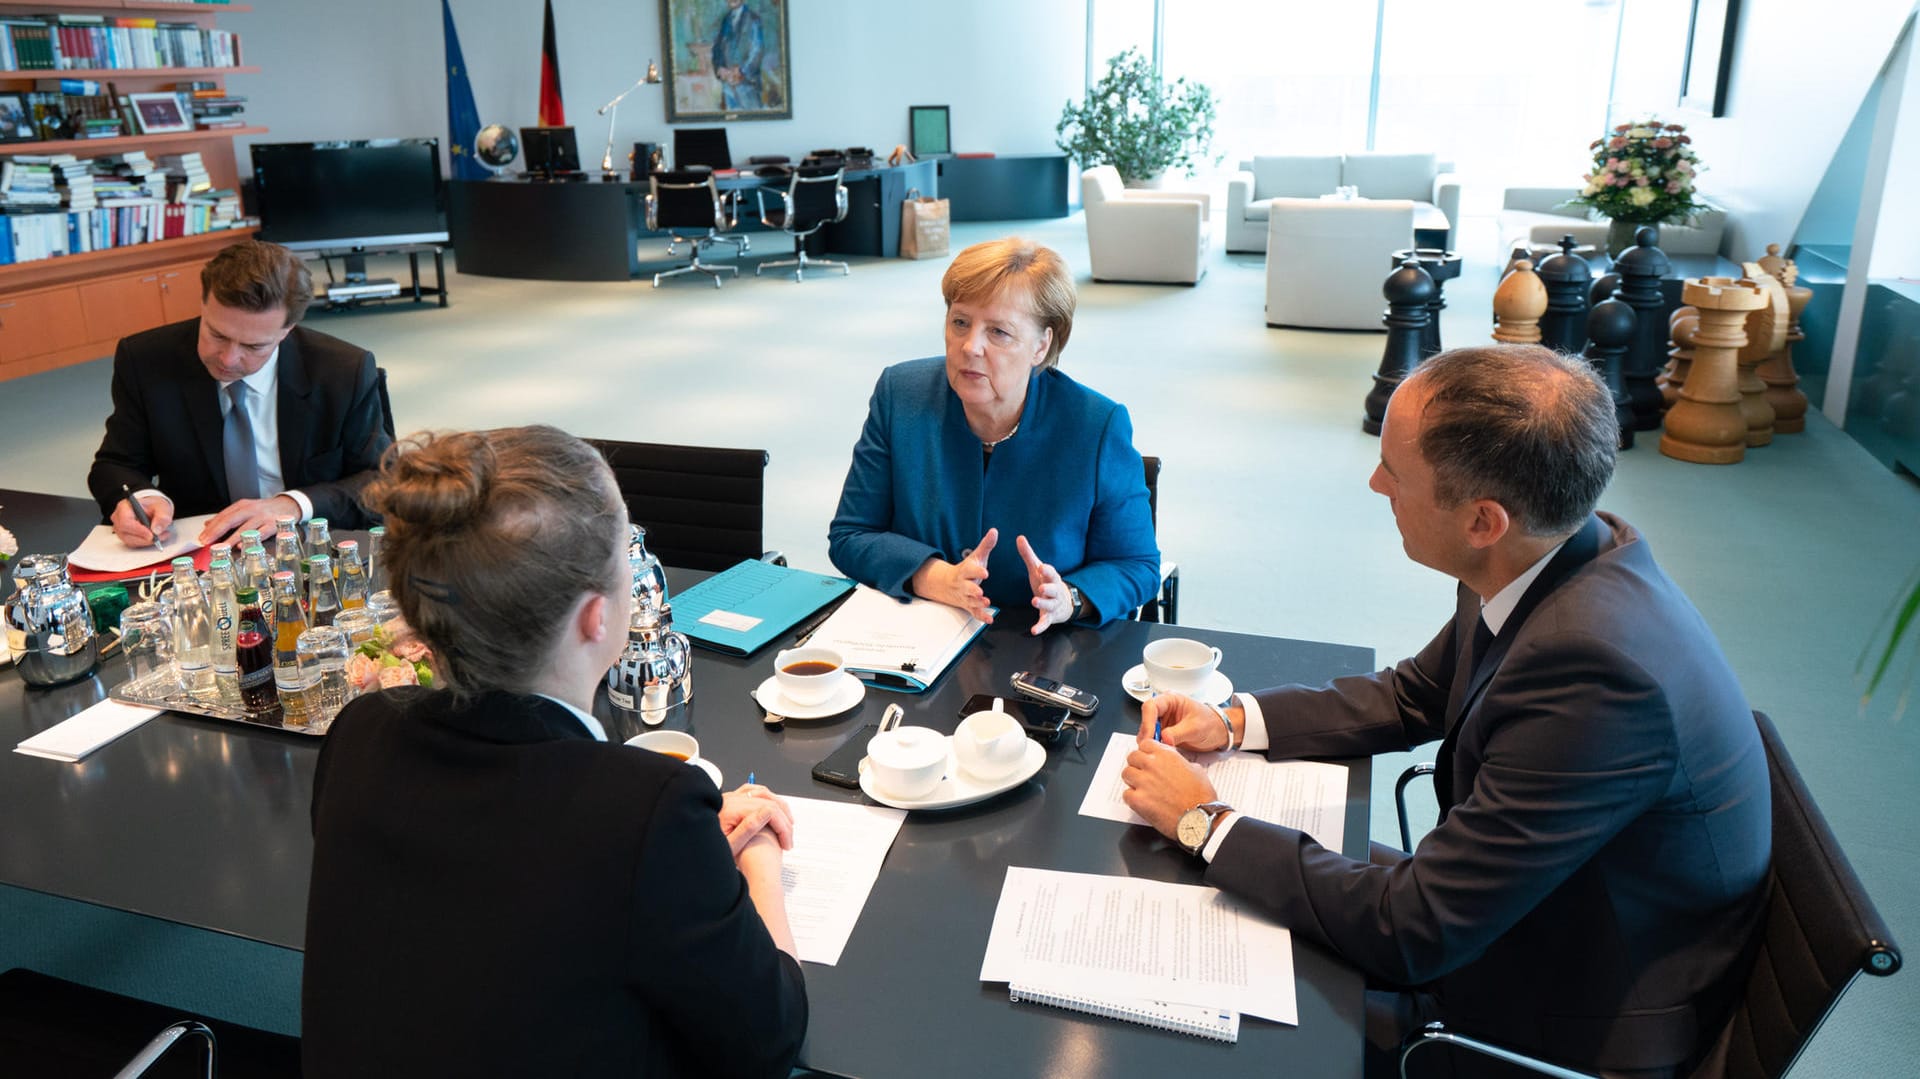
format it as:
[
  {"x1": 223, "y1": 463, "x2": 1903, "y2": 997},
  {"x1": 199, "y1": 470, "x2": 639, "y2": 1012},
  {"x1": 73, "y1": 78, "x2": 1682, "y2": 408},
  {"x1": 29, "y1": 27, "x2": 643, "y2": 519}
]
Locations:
[{"x1": 1396, "y1": 712, "x2": 1901, "y2": 1079}]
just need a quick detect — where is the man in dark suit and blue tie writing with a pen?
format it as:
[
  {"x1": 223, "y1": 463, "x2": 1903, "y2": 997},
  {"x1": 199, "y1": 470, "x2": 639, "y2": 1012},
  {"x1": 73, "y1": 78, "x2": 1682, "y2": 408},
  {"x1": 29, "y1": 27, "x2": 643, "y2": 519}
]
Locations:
[{"x1": 86, "y1": 240, "x2": 392, "y2": 547}]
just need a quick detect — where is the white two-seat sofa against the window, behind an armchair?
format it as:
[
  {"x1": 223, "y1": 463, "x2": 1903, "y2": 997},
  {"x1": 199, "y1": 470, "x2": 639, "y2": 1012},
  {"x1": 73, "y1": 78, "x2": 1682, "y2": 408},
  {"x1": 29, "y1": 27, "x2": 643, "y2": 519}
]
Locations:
[{"x1": 1227, "y1": 154, "x2": 1459, "y2": 252}]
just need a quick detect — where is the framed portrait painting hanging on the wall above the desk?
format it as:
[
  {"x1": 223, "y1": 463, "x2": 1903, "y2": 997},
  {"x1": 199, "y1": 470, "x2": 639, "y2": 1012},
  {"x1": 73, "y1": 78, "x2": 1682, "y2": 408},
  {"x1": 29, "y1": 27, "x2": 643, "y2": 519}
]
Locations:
[{"x1": 660, "y1": 0, "x2": 793, "y2": 123}]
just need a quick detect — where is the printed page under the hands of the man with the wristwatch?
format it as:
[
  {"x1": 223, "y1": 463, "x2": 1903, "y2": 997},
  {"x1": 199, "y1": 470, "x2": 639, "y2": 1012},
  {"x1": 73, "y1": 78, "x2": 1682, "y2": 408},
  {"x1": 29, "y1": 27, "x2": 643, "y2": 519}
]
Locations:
[{"x1": 1081, "y1": 731, "x2": 1346, "y2": 851}]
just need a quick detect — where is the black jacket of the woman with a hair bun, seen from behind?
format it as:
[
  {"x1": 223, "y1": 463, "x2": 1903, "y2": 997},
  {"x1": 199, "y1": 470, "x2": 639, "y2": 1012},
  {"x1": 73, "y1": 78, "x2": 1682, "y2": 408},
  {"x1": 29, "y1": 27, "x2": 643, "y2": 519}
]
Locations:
[{"x1": 301, "y1": 689, "x2": 806, "y2": 1079}]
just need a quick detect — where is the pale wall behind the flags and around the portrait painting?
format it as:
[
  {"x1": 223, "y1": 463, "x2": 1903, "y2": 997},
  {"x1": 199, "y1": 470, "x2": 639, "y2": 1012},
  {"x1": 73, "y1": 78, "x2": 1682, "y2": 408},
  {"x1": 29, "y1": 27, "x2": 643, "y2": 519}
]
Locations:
[{"x1": 221, "y1": 0, "x2": 1087, "y2": 171}]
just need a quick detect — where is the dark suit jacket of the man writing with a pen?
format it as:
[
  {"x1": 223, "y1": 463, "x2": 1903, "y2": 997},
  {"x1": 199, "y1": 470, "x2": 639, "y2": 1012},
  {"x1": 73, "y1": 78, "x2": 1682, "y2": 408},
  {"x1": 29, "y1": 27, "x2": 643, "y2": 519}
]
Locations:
[{"x1": 86, "y1": 319, "x2": 390, "y2": 528}]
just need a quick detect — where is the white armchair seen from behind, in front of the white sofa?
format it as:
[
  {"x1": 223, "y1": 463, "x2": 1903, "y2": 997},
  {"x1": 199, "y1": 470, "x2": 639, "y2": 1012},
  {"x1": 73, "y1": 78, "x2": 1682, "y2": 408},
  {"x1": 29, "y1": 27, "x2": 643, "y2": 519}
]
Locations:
[{"x1": 1267, "y1": 198, "x2": 1413, "y2": 330}]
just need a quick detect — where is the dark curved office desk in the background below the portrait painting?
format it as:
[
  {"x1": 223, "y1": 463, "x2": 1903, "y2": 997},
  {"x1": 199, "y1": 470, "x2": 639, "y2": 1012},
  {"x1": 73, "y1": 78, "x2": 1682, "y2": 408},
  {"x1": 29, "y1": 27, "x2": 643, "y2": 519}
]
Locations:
[{"x1": 447, "y1": 161, "x2": 939, "y2": 280}]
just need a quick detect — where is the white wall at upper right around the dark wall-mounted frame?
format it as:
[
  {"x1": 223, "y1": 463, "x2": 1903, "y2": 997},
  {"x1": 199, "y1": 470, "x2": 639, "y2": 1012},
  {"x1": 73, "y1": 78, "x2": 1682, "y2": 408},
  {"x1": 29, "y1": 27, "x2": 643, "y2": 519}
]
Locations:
[{"x1": 1615, "y1": 0, "x2": 1914, "y2": 261}]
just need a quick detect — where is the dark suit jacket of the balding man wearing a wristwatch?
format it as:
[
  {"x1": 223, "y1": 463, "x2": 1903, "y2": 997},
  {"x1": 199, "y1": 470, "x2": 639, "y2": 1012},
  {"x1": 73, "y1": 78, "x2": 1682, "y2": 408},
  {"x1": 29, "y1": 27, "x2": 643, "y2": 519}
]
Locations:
[{"x1": 1206, "y1": 515, "x2": 1772, "y2": 1069}]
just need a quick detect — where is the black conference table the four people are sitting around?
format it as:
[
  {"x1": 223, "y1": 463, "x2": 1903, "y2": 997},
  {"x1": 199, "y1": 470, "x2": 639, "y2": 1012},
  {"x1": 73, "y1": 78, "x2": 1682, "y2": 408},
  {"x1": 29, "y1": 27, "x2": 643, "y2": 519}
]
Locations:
[{"x1": 0, "y1": 490, "x2": 1373, "y2": 1077}]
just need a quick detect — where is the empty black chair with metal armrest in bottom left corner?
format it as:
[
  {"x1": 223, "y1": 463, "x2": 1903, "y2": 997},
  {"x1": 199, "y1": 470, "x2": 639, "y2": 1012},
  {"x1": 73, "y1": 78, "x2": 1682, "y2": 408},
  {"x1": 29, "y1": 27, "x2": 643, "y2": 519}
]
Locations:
[{"x1": 0, "y1": 968, "x2": 300, "y2": 1079}]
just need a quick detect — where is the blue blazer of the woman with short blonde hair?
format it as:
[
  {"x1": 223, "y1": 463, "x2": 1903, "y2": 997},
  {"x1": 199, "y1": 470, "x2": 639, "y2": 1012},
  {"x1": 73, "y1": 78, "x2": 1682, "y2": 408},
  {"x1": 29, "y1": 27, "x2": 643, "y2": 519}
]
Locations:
[{"x1": 828, "y1": 357, "x2": 1160, "y2": 622}]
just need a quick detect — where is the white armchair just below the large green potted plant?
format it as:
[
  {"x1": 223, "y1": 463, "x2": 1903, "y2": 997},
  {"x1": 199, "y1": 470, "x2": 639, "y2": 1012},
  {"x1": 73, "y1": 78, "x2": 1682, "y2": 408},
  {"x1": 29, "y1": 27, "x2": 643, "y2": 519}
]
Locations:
[{"x1": 1081, "y1": 165, "x2": 1213, "y2": 284}]
